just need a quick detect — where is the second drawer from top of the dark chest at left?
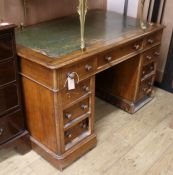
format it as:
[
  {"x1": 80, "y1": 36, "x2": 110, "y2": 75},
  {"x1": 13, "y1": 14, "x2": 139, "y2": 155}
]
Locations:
[{"x1": 0, "y1": 60, "x2": 16, "y2": 86}]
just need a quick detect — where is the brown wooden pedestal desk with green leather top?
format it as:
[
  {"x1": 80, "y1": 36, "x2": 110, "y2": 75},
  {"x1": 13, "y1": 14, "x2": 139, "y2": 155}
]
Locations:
[{"x1": 16, "y1": 10, "x2": 163, "y2": 170}]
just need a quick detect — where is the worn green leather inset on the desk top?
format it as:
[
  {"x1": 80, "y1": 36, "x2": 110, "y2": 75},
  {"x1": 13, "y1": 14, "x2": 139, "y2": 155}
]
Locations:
[{"x1": 16, "y1": 10, "x2": 140, "y2": 59}]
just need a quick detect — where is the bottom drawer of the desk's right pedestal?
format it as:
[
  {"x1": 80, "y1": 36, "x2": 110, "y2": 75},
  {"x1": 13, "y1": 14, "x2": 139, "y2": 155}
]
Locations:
[{"x1": 138, "y1": 76, "x2": 154, "y2": 99}]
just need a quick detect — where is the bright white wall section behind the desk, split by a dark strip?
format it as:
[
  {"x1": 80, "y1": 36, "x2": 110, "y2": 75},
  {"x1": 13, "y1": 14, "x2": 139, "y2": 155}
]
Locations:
[{"x1": 107, "y1": 0, "x2": 139, "y2": 17}]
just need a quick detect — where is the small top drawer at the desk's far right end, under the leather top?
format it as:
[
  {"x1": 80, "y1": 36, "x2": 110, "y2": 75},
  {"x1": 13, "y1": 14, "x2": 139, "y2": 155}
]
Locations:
[{"x1": 144, "y1": 31, "x2": 162, "y2": 48}]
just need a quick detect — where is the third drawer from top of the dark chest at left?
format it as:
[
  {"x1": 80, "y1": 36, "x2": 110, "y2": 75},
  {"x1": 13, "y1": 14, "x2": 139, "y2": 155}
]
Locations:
[{"x1": 0, "y1": 83, "x2": 19, "y2": 115}]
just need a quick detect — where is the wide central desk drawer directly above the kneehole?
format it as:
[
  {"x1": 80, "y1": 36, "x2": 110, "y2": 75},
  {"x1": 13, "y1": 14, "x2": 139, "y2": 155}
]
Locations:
[{"x1": 97, "y1": 40, "x2": 143, "y2": 68}]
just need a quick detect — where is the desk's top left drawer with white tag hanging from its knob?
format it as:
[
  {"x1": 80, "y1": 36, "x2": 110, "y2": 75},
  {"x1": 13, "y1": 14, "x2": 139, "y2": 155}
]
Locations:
[{"x1": 60, "y1": 57, "x2": 97, "y2": 88}]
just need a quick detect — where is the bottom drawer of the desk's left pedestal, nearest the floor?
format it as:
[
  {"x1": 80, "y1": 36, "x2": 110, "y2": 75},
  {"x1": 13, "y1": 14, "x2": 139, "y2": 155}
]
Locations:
[{"x1": 64, "y1": 118, "x2": 88, "y2": 145}]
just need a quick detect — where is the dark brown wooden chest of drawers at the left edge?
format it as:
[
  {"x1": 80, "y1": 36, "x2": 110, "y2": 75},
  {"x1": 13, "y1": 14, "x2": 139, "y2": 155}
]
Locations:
[{"x1": 0, "y1": 23, "x2": 30, "y2": 154}]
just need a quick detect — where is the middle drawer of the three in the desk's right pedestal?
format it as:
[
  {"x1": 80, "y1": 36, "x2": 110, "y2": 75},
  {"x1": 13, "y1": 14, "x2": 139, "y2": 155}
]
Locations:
[{"x1": 141, "y1": 62, "x2": 156, "y2": 79}]
